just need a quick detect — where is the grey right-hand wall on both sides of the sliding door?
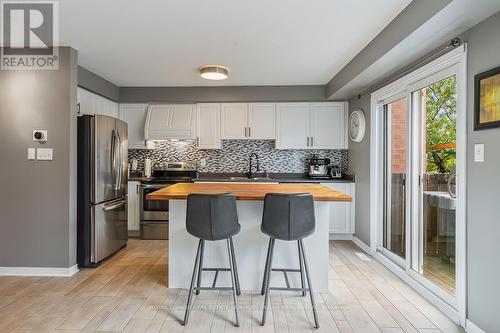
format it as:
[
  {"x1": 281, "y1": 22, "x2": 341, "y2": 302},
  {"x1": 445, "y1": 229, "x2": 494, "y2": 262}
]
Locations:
[{"x1": 349, "y1": 12, "x2": 500, "y2": 332}]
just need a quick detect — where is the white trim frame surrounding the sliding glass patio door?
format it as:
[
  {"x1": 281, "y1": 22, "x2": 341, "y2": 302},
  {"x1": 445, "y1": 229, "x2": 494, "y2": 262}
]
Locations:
[{"x1": 370, "y1": 44, "x2": 467, "y2": 326}]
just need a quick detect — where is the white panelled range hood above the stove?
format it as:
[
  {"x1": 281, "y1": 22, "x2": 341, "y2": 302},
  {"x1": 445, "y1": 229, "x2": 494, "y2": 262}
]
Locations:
[{"x1": 144, "y1": 104, "x2": 196, "y2": 141}]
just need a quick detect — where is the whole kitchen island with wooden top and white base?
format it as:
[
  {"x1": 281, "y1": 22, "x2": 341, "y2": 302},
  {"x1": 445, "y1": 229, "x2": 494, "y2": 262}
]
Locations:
[{"x1": 147, "y1": 183, "x2": 352, "y2": 292}]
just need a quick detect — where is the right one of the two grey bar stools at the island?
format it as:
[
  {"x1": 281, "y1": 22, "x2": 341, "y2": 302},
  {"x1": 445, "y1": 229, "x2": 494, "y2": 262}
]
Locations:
[{"x1": 261, "y1": 193, "x2": 319, "y2": 328}]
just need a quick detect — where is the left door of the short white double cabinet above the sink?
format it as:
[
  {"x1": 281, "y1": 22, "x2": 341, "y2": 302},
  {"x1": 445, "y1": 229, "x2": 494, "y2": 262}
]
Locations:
[{"x1": 221, "y1": 103, "x2": 248, "y2": 139}]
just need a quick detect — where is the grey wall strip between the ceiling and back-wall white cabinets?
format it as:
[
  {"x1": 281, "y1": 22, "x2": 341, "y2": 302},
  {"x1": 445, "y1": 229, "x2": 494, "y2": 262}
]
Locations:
[{"x1": 120, "y1": 85, "x2": 325, "y2": 103}]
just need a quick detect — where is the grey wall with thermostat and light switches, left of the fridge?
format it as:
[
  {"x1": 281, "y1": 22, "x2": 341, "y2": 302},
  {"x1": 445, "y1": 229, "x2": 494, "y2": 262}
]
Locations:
[{"x1": 0, "y1": 47, "x2": 77, "y2": 267}]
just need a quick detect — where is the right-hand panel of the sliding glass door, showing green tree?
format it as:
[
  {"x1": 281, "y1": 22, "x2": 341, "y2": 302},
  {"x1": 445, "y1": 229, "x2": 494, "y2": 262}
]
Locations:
[{"x1": 411, "y1": 73, "x2": 457, "y2": 296}]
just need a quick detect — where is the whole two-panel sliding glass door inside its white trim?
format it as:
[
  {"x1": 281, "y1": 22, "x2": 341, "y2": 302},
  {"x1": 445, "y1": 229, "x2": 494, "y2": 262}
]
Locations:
[{"x1": 377, "y1": 63, "x2": 465, "y2": 307}]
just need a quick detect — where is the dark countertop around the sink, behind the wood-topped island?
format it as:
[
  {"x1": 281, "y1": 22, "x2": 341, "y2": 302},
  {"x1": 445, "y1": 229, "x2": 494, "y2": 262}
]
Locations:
[{"x1": 193, "y1": 173, "x2": 354, "y2": 183}]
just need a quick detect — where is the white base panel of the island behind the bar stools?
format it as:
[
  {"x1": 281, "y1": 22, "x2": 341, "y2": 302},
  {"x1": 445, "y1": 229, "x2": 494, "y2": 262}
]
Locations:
[{"x1": 168, "y1": 200, "x2": 329, "y2": 292}]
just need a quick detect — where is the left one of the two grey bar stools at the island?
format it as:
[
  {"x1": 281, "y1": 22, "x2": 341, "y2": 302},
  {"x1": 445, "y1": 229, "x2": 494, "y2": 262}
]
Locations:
[{"x1": 184, "y1": 193, "x2": 241, "y2": 327}]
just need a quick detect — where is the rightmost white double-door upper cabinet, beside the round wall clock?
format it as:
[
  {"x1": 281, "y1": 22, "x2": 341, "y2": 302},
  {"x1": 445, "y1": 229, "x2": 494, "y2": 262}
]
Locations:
[{"x1": 276, "y1": 102, "x2": 347, "y2": 149}]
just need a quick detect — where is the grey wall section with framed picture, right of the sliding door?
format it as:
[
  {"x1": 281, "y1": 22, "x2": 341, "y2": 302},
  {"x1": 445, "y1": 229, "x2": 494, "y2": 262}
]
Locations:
[{"x1": 463, "y1": 12, "x2": 500, "y2": 332}]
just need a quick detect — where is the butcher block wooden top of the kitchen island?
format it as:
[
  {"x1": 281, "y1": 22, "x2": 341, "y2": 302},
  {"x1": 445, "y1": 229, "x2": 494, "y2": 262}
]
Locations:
[{"x1": 146, "y1": 183, "x2": 352, "y2": 202}]
